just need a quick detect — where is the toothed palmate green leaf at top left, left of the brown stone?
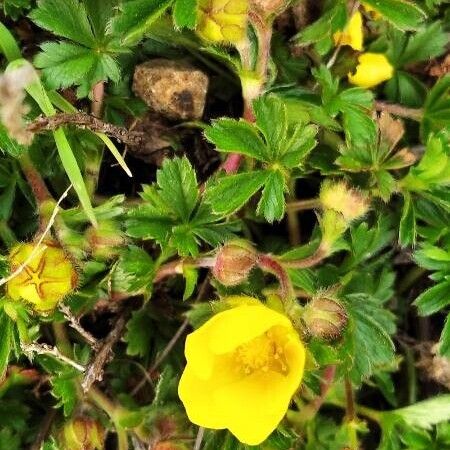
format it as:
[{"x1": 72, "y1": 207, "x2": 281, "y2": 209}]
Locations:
[{"x1": 31, "y1": 0, "x2": 120, "y2": 97}]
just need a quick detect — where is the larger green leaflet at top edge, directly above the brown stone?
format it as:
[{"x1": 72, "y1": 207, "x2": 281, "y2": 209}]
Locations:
[{"x1": 112, "y1": 0, "x2": 173, "y2": 45}]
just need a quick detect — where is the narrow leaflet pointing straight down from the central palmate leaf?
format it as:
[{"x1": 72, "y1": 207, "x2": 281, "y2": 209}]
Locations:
[{"x1": 257, "y1": 170, "x2": 286, "y2": 223}]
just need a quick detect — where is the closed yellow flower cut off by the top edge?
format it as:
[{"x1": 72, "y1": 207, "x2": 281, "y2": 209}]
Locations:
[{"x1": 197, "y1": 0, "x2": 248, "y2": 43}]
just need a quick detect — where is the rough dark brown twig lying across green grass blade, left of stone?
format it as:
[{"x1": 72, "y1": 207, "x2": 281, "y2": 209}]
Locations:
[{"x1": 27, "y1": 113, "x2": 144, "y2": 146}]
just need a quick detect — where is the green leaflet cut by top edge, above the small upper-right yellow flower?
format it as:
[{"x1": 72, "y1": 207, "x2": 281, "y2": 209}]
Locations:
[{"x1": 365, "y1": 0, "x2": 426, "y2": 31}]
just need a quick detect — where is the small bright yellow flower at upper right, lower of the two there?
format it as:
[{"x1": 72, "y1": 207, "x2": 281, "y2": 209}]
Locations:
[{"x1": 348, "y1": 53, "x2": 394, "y2": 88}]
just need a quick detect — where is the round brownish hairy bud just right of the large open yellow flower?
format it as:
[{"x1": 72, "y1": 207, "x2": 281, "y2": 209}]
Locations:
[{"x1": 302, "y1": 295, "x2": 347, "y2": 339}]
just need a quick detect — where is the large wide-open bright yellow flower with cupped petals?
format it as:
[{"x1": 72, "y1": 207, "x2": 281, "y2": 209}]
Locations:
[{"x1": 178, "y1": 297, "x2": 305, "y2": 445}]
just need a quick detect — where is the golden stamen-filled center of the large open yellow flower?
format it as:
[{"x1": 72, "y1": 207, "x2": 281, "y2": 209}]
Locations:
[{"x1": 234, "y1": 330, "x2": 288, "y2": 375}]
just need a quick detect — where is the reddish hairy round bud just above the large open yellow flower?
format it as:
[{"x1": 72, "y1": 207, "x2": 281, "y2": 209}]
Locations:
[{"x1": 213, "y1": 241, "x2": 257, "y2": 286}]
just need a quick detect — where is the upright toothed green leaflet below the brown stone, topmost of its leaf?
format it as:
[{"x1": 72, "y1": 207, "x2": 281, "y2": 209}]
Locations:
[{"x1": 156, "y1": 157, "x2": 198, "y2": 222}]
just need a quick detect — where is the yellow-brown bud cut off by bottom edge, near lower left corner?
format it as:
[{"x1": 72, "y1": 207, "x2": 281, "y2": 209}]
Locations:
[{"x1": 61, "y1": 417, "x2": 105, "y2": 450}]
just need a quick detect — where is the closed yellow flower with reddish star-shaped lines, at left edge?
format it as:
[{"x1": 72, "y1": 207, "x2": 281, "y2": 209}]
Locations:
[{"x1": 7, "y1": 240, "x2": 77, "y2": 312}]
